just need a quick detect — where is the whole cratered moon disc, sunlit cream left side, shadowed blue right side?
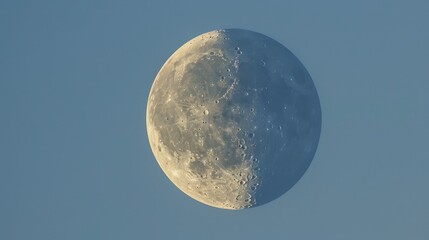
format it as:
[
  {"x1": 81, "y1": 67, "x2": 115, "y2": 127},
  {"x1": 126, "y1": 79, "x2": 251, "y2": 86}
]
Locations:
[{"x1": 146, "y1": 29, "x2": 321, "y2": 209}]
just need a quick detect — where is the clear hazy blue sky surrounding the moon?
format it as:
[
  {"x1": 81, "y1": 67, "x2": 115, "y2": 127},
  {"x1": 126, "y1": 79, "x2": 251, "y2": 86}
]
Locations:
[{"x1": 0, "y1": 0, "x2": 429, "y2": 240}]
